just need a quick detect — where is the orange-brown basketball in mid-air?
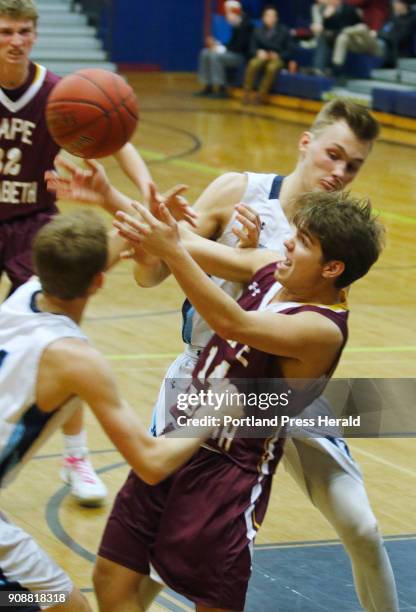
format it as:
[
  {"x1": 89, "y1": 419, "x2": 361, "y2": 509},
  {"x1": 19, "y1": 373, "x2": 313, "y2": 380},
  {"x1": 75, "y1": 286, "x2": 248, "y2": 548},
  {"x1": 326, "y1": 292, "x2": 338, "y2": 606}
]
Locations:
[{"x1": 46, "y1": 68, "x2": 139, "y2": 158}]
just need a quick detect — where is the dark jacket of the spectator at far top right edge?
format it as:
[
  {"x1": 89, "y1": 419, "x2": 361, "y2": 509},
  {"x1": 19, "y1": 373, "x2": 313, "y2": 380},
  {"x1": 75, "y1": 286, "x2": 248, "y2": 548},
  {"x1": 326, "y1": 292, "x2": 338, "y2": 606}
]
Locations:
[{"x1": 378, "y1": 10, "x2": 416, "y2": 65}]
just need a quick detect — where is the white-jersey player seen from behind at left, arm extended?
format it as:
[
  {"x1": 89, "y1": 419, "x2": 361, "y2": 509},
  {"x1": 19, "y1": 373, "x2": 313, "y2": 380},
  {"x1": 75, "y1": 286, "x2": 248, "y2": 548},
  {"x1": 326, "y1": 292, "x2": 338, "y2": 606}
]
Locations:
[{"x1": 0, "y1": 212, "x2": 234, "y2": 612}]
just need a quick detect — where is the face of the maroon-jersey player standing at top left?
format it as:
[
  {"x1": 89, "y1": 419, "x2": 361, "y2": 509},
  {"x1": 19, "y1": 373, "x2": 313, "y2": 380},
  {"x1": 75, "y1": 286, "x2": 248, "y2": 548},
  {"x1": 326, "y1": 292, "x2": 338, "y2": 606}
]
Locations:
[{"x1": 0, "y1": 17, "x2": 36, "y2": 67}]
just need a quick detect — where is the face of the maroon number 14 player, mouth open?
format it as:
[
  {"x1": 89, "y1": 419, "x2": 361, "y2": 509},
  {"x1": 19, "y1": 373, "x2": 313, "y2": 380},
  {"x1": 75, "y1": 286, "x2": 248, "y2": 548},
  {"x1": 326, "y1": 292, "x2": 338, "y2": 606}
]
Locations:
[{"x1": 274, "y1": 228, "x2": 325, "y2": 295}]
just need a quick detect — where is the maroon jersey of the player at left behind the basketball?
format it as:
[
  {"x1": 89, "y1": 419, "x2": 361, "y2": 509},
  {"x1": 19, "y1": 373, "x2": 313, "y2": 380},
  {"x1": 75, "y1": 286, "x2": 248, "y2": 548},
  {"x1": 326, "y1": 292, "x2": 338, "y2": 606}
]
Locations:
[{"x1": 0, "y1": 64, "x2": 59, "y2": 221}]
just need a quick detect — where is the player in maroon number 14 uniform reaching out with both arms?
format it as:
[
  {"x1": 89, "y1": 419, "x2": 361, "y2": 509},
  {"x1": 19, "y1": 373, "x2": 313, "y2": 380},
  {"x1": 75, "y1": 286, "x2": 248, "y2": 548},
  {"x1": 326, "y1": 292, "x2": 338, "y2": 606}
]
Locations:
[{"x1": 94, "y1": 192, "x2": 383, "y2": 612}]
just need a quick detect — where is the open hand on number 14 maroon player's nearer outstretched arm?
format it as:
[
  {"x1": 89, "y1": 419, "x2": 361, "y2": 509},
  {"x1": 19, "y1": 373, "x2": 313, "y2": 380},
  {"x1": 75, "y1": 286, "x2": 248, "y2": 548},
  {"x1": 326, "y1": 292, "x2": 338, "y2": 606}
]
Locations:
[{"x1": 113, "y1": 202, "x2": 180, "y2": 259}]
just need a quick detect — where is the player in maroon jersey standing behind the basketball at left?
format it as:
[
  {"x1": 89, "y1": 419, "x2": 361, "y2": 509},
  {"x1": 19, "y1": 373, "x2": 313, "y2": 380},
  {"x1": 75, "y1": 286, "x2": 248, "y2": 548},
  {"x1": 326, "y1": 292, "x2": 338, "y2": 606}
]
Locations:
[{"x1": 0, "y1": 0, "x2": 151, "y2": 505}]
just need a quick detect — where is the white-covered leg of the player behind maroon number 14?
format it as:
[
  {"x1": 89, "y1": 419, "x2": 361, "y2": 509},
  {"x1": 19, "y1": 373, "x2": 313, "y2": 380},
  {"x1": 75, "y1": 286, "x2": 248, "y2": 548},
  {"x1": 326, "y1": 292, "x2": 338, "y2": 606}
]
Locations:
[{"x1": 285, "y1": 438, "x2": 398, "y2": 612}]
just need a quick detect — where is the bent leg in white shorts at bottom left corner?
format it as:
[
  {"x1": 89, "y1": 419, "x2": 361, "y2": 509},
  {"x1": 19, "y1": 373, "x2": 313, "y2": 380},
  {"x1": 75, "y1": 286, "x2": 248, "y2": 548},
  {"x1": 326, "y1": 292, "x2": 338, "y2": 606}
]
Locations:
[{"x1": 0, "y1": 514, "x2": 91, "y2": 612}]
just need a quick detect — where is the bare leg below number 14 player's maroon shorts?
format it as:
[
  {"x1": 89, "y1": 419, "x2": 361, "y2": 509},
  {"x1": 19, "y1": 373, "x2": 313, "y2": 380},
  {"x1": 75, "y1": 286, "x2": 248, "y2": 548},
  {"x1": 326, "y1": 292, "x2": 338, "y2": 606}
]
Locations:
[{"x1": 93, "y1": 556, "x2": 162, "y2": 612}]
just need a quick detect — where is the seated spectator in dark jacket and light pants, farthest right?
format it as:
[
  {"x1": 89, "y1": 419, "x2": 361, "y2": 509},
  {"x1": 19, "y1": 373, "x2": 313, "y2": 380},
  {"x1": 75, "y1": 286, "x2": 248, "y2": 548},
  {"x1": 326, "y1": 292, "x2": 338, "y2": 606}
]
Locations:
[{"x1": 332, "y1": 0, "x2": 416, "y2": 78}]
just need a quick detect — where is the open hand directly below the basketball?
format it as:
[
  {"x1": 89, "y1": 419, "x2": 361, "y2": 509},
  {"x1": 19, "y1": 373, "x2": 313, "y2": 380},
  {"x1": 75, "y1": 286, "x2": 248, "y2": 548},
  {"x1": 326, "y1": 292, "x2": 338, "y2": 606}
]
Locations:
[{"x1": 45, "y1": 155, "x2": 111, "y2": 205}]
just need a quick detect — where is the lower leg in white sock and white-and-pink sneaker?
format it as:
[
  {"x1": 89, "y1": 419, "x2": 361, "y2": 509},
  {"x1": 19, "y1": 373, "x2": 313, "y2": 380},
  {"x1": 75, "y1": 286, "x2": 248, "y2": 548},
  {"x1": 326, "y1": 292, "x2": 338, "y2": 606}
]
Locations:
[{"x1": 61, "y1": 400, "x2": 107, "y2": 506}]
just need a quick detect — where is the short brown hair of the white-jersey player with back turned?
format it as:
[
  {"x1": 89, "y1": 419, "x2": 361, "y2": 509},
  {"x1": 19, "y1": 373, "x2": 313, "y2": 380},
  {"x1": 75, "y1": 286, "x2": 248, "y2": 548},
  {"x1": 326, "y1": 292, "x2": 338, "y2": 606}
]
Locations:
[{"x1": 33, "y1": 211, "x2": 108, "y2": 300}]
